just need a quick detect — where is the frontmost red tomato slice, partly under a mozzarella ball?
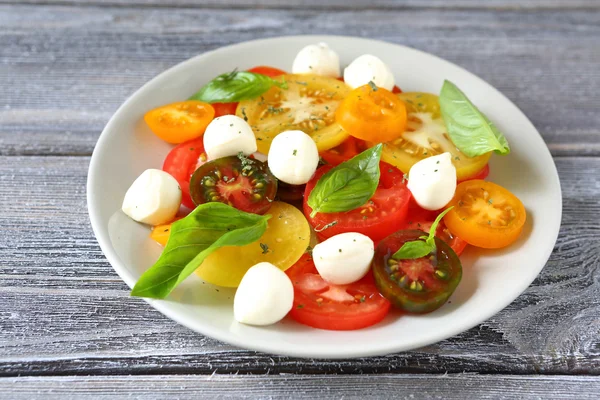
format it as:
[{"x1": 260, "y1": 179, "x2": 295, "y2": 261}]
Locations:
[{"x1": 287, "y1": 254, "x2": 390, "y2": 331}]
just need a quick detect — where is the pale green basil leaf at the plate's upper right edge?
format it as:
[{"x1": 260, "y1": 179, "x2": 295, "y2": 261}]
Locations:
[{"x1": 439, "y1": 81, "x2": 510, "y2": 157}]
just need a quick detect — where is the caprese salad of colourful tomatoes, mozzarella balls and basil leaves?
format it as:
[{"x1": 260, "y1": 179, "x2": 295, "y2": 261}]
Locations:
[{"x1": 122, "y1": 43, "x2": 526, "y2": 330}]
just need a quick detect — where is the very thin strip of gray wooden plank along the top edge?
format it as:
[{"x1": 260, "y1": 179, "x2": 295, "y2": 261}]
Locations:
[{"x1": 0, "y1": 0, "x2": 600, "y2": 10}]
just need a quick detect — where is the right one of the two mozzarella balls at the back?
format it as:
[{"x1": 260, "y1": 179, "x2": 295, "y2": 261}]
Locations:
[{"x1": 344, "y1": 54, "x2": 395, "y2": 90}]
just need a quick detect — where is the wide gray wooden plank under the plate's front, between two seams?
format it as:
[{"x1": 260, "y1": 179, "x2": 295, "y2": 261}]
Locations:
[{"x1": 0, "y1": 156, "x2": 600, "y2": 376}]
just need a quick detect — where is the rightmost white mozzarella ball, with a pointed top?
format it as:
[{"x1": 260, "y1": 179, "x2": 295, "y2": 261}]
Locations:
[{"x1": 407, "y1": 152, "x2": 456, "y2": 210}]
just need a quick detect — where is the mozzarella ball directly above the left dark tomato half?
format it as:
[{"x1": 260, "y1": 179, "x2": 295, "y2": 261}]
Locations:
[{"x1": 204, "y1": 115, "x2": 257, "y2": 160}]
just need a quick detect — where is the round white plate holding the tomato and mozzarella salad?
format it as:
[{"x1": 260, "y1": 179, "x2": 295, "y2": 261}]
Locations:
[{"x1": 87, "y1": 36, "x2": 562, "y2": 358}]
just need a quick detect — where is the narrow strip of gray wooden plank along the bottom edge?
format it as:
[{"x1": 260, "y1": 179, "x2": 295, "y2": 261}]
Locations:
[{"x1": 0, "y1": 374, "x2": 600, "y2": 400}]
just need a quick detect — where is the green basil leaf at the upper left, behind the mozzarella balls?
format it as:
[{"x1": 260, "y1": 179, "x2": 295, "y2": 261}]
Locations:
[{"x1": 190, "y1": 71, "x2": 287, "y2": 103}]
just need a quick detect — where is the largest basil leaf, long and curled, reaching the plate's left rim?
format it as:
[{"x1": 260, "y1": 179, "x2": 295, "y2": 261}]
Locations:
[{"x1": 131, "y1": 202, "x2": 270, "y2": 299}]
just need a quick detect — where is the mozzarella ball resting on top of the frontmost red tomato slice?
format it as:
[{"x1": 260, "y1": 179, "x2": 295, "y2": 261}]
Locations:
[{"x1": 313, "y1": 232, "x2": 375, "y2": 285}]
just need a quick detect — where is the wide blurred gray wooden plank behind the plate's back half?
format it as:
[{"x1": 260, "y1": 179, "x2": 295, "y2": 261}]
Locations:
[{"x1": 0, "y1": 6, "x2": 600, "y2": 155}]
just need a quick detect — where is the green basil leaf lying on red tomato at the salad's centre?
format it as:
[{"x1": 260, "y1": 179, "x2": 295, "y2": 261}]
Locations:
[{"x1": 308, "y1": 143, "x2": 383, "y2": 217}]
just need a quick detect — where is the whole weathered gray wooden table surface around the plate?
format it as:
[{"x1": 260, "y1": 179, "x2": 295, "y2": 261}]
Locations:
[{"x1": 0, "y1": 0, "x2": 600, "y2": 400}]
